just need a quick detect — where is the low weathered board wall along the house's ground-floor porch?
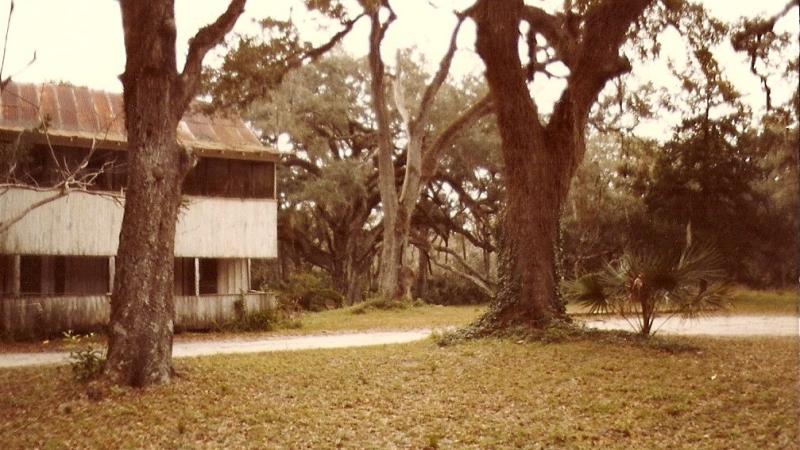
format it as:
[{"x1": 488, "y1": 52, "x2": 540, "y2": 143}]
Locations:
[{"x1": 0, "y1": 293, "x2": 276, "y2": 338}]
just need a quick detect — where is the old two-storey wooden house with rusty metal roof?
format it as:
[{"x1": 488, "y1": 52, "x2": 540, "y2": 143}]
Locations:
[{"x1": 0, "y1": 83, "x2": 277, "y2": 335}]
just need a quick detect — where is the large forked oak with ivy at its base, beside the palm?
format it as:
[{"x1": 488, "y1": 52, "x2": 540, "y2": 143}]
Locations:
[{"x1": 469, "y1": 0, "x2": 655, "y2": 330}]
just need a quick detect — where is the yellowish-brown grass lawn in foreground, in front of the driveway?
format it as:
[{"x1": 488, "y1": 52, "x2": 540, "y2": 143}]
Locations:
[{"x1": 0, "y1": 338, "x2": 799, "y2": 449}]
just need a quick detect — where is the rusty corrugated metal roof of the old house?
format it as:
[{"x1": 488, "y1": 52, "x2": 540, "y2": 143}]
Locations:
[{"x1": 0, "y1": 83, "x2": 277, "y2": 159}]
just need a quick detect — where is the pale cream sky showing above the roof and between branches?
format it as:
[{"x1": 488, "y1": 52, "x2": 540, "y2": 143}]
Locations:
[{"x1": 0, "y1": 0, "x2": 798, "y2": 138}]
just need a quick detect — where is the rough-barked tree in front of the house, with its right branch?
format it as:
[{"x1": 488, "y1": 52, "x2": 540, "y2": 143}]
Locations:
[{"x1": 104, "y1": 0, "x2": 245, "y2": 386}]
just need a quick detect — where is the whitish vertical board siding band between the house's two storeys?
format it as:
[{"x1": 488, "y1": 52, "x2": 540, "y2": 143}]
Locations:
[{"x1": 0, "y1": 188, "x2": 278, "y2": 258}]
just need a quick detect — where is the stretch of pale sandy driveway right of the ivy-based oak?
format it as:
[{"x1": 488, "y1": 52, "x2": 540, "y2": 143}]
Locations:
[{"x1": 584, "y1": 316, "x2": 800, "y2": 336}]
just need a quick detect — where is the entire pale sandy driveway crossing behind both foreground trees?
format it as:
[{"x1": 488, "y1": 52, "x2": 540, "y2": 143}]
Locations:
[{"x1": 0, "y1": 316, "x2": 799, "y2": 368}]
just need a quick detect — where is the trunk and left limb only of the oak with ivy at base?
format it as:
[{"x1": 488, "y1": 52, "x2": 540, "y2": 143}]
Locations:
[{"x1": 476, "y1": 1, "x2": 572, "y2": 328}]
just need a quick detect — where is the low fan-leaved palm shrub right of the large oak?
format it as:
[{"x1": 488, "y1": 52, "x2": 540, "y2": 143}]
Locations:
[{"x1": 564, "y1": 234, "x2": 727, "y2": 336}]
